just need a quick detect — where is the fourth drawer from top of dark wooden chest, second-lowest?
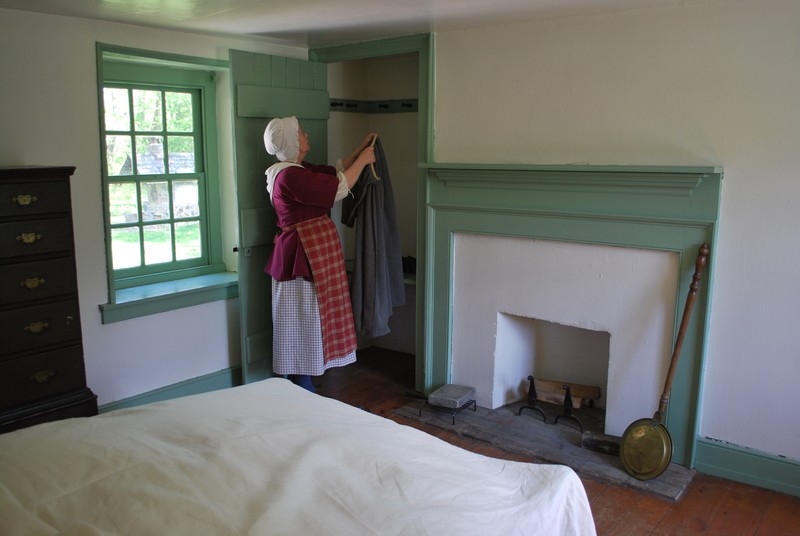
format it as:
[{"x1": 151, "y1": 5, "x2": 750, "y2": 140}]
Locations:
[{"x1": 0, "y1": 300, "x2": 81, "y2": 360}]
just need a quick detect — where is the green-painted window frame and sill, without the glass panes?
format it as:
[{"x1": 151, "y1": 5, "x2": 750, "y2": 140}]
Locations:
[{"x1": 97, "y1": 43, "x2": 233, "y2": 324}]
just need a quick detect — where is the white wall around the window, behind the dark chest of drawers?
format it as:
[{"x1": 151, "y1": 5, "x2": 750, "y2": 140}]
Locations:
[{"x1": 0, "y1": 9, "x2": 306, "y2": 404}]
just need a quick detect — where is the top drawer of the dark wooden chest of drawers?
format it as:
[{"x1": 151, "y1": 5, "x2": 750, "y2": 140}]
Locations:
[{"x1": 0, "y1": 180, "x2": 71, "y2": 217}]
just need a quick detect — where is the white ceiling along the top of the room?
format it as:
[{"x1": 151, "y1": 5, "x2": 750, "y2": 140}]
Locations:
[{"x1": 0, "y1": 0, "x2": 687, "y2": 47}]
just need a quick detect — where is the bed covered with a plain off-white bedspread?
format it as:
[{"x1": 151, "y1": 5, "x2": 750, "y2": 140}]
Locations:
[{"x1": 0, "y1": 378, "x2": 595, "y2": 536}]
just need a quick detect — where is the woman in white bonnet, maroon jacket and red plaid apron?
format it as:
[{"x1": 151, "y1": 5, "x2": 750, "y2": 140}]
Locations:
[{"x1": 264, "y1": 117, "x2": 375, "y2": 392}]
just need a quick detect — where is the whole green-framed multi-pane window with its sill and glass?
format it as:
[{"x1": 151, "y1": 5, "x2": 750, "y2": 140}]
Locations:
[{"x1": 98, "y1": 45, "x2": 235, "y2": 323}]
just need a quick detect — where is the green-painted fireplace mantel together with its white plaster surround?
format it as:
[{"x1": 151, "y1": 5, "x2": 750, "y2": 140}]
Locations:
[{"x1": 424, "y1": 164, "x2": 722, "y2": 467}]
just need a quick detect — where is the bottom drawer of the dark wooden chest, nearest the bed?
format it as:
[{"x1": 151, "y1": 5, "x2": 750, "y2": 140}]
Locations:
[{"x1": 0, "y1": 346, "x2": 86, "y2": 411}]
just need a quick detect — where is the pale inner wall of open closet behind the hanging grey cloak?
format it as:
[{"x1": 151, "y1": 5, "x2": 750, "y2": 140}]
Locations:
[{"x1": 328, "y1": 54, "x2": 419, "y2": 354}]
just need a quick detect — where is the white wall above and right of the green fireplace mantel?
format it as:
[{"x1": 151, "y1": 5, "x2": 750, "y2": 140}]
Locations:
[{"x1": 435, "y1": 0, "x2": 800, "y2": 460}]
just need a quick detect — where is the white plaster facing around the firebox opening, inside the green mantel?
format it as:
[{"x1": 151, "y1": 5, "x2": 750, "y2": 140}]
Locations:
[{"x1": 452, "y1": 234, "x2": 678, "y2": 436}]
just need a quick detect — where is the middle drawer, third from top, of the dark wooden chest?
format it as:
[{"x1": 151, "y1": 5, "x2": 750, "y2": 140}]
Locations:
[{"x1": 0, "y1": 257, "x2": 78, "y2": 306}]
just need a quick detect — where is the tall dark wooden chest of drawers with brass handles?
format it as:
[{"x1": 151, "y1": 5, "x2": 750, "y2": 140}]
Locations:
[{"x1": 0, "y1": 166, "x2": 97, "y2": 433}]
